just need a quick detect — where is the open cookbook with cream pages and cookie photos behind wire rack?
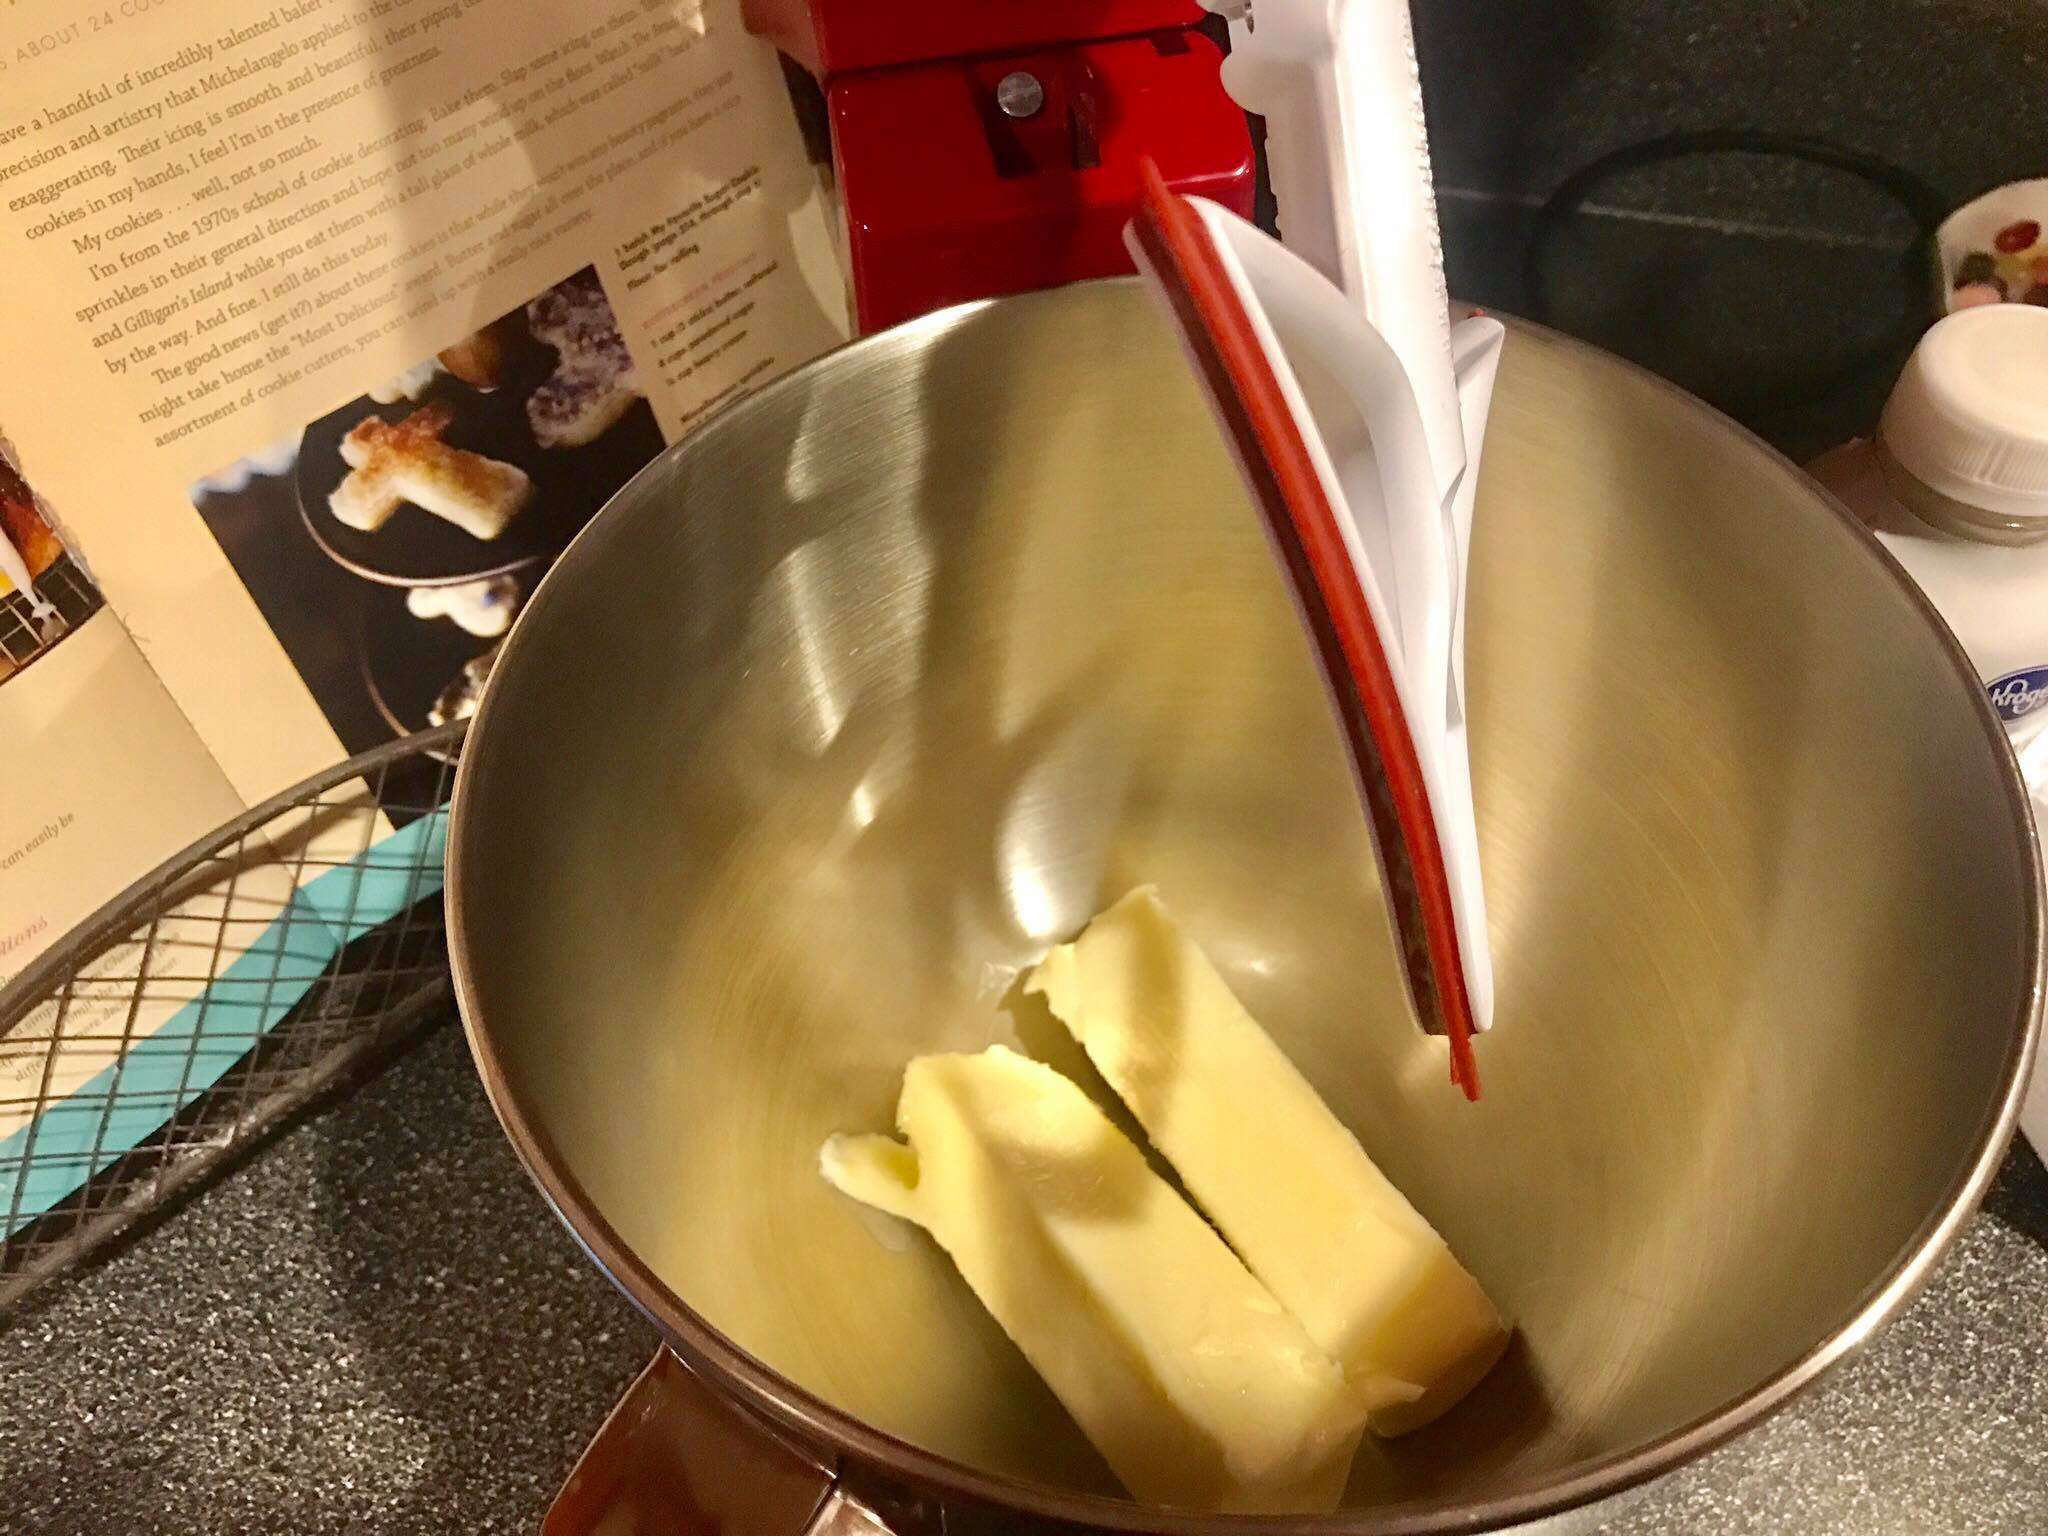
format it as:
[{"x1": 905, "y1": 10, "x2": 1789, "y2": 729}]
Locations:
[{"x1": 0, "y1": 0, "x2": 846, "y2": 1235}]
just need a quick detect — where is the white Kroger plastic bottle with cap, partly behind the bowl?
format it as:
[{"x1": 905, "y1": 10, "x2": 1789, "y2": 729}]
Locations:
[{"x1": 1808, "y1": 305, "x2": 2048, "y2": 753}]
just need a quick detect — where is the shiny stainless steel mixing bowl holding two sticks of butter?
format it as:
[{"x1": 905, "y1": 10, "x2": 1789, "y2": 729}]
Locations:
[{"x1": 449, "y1": 283, "x2": 2042, "y2": 1536}]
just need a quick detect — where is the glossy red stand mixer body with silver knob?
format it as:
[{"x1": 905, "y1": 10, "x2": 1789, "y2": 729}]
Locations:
[{"x1": 743, "y1": 0, "x2": 1253, "y2": 334}]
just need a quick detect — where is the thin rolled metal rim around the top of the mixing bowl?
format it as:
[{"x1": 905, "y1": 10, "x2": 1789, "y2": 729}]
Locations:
[{"x1": 444, "y1": 276, "x2": 2048, "y2": 1536}]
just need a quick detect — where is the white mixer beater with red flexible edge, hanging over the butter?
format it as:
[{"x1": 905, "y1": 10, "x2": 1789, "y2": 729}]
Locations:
[{"x1": 1126, "y1": 0, "x2": 1503, "y2": 1098}]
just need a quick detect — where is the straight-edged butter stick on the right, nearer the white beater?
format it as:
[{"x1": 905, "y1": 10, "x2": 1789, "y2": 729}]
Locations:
[{"x1": 1024, "y1": 887, "x2": 1507, "y2": 1436}]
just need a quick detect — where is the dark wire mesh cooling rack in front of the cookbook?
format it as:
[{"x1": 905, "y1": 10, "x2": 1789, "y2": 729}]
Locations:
[{"x1": 0, "y1": 723, "x2": 467, "y2": 1325}]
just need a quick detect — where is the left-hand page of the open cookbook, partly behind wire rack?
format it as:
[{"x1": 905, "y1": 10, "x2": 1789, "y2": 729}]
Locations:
[{"x1": 0, "y1": 432, "x2": 299, "y2": 1237}]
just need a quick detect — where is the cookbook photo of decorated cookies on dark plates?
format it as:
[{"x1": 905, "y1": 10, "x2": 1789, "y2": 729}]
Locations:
[{"x1": 193, "y1": 266, "x2": 664, "y2": 752}]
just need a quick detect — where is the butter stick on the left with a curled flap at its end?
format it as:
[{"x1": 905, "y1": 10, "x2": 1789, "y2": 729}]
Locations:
[{"x1": 819, "y1": 1047, "x2": 1364, "y2": 1513}]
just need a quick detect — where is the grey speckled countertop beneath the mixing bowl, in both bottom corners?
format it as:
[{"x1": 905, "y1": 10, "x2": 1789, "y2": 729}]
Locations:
[{"x1": 0, "y1": 1028, "x2": 2048, "y2": 1536}]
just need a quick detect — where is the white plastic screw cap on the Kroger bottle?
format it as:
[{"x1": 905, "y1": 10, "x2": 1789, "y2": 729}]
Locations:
[{"x1": 1878, "y1": 303, "x2": 2048, "y2": 520}]
